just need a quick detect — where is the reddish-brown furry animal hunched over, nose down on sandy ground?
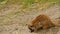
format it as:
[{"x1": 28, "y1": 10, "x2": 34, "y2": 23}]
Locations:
[{"x1": 27, "y1": 14, "x2": 59, "y2": 32}]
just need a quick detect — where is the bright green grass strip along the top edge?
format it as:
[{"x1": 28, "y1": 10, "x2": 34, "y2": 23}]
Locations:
[{"x1": 19, "y1": 0, "x2": 60, "y2": 8}]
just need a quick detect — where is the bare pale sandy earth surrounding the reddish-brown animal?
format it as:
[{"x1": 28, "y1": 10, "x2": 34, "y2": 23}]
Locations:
[{"x1": 0, "y1": 4, "x2": 60, "y2": 34}]
